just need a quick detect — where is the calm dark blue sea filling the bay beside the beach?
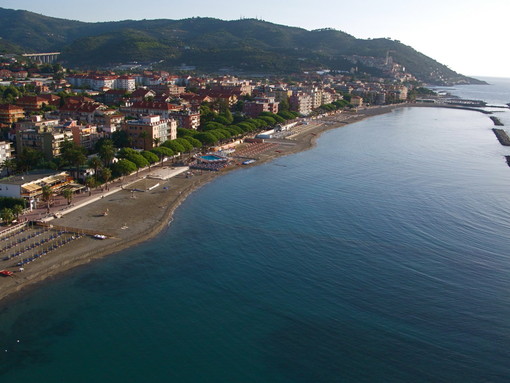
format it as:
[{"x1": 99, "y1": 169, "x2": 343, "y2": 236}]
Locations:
[{"x1": 0, "y1": 78, "x2": 510, "y2": 383}]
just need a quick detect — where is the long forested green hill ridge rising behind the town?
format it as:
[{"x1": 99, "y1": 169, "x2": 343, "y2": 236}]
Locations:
[{"x1": 0, "y1": 8, "x2": 484, "y2": 84}]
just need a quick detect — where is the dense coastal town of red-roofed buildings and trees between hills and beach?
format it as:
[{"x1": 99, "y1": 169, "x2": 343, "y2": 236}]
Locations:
[{"x1": 0, "y1": 54, "x2": 422, "y2": 230}]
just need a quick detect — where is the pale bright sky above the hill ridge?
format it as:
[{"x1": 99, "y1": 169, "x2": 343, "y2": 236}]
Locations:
[{"x1": 0, "y1": 0, "x2": 510, "y2": 78}]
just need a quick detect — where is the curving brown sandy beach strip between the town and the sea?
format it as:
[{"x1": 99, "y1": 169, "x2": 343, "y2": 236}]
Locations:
[{"x1": 0, "y1": 105, "x2": 402, "y2": 302}]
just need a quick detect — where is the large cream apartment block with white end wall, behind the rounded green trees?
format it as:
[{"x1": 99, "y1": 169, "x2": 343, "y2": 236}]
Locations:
[{"x1": 122, "y1": 115, "x2": 177, "y2": 150}]
